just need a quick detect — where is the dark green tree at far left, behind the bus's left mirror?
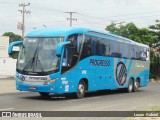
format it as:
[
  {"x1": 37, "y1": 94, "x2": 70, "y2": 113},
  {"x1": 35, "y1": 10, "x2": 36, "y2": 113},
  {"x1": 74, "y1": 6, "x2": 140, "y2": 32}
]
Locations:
[{"x1": 2, "y1": 32, "x2": 22, "y2": 59}]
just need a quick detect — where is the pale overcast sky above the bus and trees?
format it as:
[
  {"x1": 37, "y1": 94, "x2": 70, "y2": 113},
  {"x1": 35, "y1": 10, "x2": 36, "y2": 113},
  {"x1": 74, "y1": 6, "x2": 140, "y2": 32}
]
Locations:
[{"x1": 0, "y1": 0, "x2": 160, "y2": 36}]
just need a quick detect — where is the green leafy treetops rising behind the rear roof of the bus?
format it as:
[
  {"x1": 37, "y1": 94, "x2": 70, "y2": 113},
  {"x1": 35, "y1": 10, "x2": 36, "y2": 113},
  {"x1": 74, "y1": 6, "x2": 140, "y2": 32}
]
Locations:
[{"x1": 106, "y1": 22, "x2": 156, "y2": 45}]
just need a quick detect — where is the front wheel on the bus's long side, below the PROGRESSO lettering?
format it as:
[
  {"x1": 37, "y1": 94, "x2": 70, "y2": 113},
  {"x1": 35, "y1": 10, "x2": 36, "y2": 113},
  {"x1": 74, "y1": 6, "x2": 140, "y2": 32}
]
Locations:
[{"x1": 76, "y1": 80, "x2": 86, "y2": 98}]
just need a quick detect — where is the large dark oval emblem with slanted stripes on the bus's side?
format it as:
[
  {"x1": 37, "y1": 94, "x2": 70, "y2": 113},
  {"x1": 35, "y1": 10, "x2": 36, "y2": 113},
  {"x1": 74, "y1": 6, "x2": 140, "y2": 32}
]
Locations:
[{"x1": 116, "y1": 62, "x2": 127, "y2": 86}]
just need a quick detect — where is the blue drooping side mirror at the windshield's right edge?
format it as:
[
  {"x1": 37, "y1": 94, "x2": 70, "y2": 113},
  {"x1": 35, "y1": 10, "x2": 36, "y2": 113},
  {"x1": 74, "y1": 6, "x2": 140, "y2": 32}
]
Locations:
[{"x1": 56, "y1": 41, "x2": 71, "y2": 57}]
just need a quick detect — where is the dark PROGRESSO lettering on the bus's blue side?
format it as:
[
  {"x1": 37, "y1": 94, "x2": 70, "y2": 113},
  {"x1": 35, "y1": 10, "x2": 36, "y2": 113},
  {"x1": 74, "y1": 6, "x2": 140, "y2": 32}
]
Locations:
[{"x1": 89, "y1": 59, "x2": 110, "y2": 66}]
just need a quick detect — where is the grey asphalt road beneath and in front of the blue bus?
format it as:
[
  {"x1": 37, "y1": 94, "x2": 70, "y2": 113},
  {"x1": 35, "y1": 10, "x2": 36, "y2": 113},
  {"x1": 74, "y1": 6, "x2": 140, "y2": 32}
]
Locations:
[{"x1": 0, "y1": 82, "x2": 160, "y2": 119}]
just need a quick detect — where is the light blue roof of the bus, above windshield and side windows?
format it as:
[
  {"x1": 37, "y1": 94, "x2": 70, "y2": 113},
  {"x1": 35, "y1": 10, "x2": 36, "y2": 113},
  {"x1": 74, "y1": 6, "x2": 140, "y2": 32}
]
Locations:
[{"x1": 26, "y1": 27, "x2": 149, "y2": 48}]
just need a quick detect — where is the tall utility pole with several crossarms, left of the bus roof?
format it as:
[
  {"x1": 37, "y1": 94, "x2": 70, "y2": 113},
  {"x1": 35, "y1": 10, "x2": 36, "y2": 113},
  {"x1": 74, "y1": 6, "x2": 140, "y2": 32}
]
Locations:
[{"x1": 18, "y1": 3, "x2": 31, "y2": 38}]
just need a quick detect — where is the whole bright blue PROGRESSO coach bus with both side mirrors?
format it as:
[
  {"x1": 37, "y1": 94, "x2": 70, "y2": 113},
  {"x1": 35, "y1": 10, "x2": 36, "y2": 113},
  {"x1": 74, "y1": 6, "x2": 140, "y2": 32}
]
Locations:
[{"x1": 8, "y1": 27, "x2": 150, "y2": 98}]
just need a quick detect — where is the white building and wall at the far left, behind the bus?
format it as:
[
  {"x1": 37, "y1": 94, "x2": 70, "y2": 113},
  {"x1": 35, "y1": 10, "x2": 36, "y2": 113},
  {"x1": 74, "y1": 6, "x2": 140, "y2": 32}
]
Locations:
[{"x1": 0, "y1": 36, "x2": 17, "y2": 78}]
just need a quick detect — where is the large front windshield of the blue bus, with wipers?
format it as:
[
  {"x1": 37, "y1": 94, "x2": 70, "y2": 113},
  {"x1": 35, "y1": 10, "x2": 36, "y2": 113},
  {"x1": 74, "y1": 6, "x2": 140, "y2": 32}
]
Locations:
[{"x1": 17, "y1": 37, "x2": 63, "y2": 72}]
